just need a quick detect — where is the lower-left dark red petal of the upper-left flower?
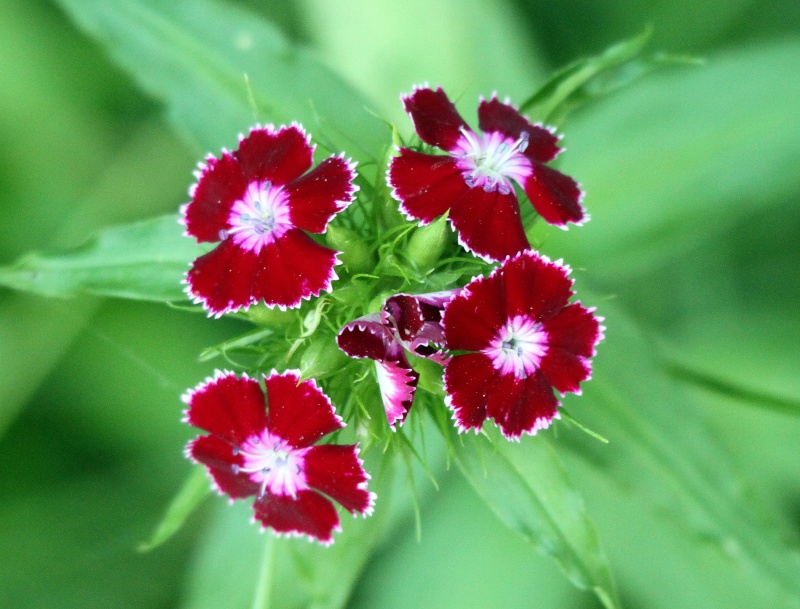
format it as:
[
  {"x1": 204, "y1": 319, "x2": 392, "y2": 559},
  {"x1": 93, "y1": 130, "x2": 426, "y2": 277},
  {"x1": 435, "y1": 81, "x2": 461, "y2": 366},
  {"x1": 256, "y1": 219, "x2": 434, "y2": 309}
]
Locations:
[{"x1": 186, "y1": 238, "x2": 258, "y2": 316}]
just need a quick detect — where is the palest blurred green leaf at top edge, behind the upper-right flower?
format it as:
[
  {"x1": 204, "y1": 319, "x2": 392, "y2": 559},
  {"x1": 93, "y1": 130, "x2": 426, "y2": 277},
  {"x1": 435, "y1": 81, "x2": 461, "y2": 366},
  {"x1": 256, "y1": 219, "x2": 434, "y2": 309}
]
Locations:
[{"x1": 300, "y1": 0, "x2": 547, "y2": 123}]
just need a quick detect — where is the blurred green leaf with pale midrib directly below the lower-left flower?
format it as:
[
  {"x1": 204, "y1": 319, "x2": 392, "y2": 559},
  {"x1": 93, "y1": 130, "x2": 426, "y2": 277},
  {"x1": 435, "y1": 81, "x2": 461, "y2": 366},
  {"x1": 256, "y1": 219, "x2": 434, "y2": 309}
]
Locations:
[{"x1": 183, "y1": 452, "x2": 398, "y2": 609}]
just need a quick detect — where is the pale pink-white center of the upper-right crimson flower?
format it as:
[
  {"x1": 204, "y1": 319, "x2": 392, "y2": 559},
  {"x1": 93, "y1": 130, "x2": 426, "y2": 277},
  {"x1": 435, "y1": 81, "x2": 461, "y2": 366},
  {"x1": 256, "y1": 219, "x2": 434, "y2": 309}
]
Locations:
[{"x1": 452, "y1": 127, "x2": 532, "y2": 195}]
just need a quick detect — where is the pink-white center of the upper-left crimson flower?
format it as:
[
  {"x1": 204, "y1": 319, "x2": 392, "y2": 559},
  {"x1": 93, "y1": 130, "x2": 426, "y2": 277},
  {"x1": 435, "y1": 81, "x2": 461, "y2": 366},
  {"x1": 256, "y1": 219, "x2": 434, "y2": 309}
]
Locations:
[{"x1": 227, "y1": 180, "x2": 292, "y2": 254}]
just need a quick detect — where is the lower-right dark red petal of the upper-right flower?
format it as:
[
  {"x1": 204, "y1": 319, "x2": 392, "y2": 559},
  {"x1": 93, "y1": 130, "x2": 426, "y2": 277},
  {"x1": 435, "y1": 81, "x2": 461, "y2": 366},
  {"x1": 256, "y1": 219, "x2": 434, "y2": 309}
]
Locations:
[{"x1": 523, "y1": 163, "x2": 588, "y2": 226}]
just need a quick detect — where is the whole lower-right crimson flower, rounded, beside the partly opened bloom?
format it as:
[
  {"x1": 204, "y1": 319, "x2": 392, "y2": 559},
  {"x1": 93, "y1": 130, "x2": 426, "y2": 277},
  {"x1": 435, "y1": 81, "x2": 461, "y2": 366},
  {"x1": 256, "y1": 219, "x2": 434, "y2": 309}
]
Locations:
[{"x1": 442, "y1": 250, "x2": 603, "y2": 439}]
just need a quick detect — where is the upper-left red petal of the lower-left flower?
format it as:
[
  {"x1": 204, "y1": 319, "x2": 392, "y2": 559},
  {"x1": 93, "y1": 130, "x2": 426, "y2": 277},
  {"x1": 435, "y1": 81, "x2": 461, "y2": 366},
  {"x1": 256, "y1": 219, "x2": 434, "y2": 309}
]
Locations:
[{"x1": 183, "y1": 372, "x2": 267, "y2": 446}]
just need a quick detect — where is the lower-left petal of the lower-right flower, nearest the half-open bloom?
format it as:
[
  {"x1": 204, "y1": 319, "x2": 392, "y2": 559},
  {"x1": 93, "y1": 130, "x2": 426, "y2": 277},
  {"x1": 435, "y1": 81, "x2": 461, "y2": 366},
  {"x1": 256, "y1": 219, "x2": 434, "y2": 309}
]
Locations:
[{"x1": 444, "y1": 353, "x2": 499, "y2": 431}]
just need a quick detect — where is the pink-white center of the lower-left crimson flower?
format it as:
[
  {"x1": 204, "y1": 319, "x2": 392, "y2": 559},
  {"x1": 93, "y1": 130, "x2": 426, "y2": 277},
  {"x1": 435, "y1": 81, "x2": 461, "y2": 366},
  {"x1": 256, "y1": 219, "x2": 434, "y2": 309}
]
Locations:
[{"x1": 233, "y1": 429, "x2": 308, "y2": 497}]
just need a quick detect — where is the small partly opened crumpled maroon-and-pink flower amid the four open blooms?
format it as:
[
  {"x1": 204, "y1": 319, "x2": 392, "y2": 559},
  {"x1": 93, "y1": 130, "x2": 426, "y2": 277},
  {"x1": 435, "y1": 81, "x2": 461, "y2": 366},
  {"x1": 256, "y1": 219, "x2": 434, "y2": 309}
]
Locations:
[{"x1": 336, "y1": 291, "x2": 455, "y2": 430}]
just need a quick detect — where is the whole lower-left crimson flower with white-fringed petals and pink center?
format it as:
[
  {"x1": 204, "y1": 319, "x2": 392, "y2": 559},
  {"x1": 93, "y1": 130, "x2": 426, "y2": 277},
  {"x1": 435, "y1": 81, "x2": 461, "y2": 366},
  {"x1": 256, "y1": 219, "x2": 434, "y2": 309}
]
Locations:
[{"x1": 183, "y1": 370, "x2": 375, "y2": 544}]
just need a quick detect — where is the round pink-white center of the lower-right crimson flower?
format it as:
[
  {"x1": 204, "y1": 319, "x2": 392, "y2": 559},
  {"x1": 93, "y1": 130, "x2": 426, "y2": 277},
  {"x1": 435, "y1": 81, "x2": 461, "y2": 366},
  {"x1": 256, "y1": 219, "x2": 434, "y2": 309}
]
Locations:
[{"x1": 484, "y1": 315, "x2": 548, "y2": 379}]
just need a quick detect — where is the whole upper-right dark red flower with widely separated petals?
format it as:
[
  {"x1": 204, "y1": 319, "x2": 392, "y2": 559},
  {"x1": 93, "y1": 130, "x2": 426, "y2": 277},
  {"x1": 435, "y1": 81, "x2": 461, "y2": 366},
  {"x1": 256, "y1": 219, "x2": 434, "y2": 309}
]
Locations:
[{"x1": 388, "y1": 87, "x2": 588, "y2": 261}]
